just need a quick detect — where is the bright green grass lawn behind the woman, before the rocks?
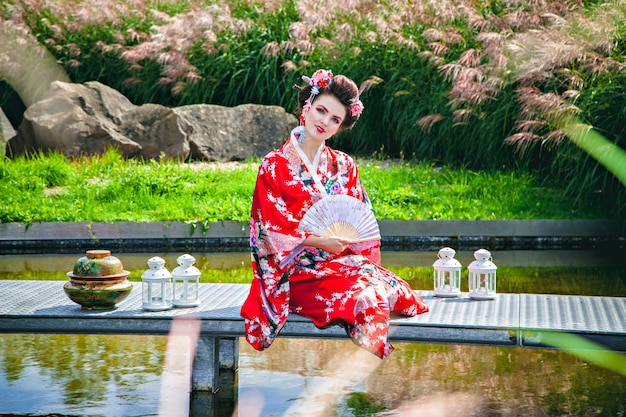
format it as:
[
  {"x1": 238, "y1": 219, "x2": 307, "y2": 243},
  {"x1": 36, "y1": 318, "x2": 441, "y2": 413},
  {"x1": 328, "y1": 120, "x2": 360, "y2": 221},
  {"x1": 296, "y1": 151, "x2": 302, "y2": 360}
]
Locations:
[{"x1": 0, "y1": 151, "x2": 606, "y2": 224}]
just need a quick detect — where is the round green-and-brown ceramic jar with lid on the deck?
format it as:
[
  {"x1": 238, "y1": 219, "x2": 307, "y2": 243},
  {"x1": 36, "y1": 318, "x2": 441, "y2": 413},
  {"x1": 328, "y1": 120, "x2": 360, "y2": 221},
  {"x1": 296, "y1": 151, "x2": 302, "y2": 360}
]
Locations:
[{"x1": 63, "y1": 250, "x2": 133, "y2": 310}]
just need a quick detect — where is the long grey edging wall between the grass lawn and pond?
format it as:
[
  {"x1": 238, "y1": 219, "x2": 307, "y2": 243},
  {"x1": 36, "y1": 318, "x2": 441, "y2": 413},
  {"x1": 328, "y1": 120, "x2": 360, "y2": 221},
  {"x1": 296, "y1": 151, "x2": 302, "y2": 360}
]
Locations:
[{"x1": 0, "y1": 220, "x2": 626, "y2": 253}]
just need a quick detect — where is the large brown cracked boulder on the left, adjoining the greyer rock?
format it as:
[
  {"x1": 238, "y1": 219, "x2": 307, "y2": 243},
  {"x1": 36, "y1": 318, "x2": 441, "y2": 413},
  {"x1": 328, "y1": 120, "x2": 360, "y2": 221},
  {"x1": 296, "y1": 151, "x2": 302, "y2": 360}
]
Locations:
[{"x1": 7, "y1": 81, "x2": 189, "y2": 158}]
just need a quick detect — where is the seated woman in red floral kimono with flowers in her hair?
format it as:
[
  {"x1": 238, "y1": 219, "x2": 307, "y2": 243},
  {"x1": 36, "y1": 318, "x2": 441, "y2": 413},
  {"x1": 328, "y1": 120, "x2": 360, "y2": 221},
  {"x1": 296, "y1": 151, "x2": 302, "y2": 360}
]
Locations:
[{"x1": 236, "y1": 70, "x2": 428, "y2": 358}]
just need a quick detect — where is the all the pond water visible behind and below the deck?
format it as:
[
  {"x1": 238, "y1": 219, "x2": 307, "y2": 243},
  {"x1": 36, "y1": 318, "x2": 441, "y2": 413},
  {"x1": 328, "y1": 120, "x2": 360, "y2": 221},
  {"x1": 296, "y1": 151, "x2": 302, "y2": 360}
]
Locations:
[{"x1": 0, "y1": 251, "x2": 626, "y2": 417}]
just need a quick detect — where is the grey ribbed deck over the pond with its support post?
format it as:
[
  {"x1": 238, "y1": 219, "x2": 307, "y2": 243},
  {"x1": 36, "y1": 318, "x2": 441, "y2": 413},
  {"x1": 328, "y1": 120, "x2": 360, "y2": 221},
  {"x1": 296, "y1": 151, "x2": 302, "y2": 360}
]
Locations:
[{"x1": 0, "y1": 280, "x2": 626, "y2": 391}]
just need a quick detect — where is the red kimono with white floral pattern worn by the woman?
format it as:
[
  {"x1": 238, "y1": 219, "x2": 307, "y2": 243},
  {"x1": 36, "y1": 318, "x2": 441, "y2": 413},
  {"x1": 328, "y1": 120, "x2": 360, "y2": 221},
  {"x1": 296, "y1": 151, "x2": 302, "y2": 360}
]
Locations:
[{"x1": 241, "y1": 129, "x2": 428, "y2": 358}]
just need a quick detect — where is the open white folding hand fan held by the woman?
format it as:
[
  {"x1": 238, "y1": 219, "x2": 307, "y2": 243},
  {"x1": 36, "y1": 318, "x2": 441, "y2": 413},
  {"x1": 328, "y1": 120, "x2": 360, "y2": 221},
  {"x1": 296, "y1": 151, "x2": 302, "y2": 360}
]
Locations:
[{"x1": 300, "y1": 195, "x2": 380, "y2": 242}]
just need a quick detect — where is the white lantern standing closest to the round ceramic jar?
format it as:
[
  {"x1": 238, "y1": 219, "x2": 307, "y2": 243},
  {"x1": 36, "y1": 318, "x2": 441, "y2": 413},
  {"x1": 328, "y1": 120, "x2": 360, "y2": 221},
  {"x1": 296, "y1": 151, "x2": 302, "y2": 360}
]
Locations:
[{"x1": 141, "y1": 256, "x2": 172, "y2": 311}]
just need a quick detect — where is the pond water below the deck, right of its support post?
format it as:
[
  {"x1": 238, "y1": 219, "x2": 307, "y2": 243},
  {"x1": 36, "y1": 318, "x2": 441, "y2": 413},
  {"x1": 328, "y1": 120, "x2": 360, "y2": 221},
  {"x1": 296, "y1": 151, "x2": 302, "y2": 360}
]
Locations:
[{"x1": 239, "y1": 339, "x2": 626, "y2": 417}]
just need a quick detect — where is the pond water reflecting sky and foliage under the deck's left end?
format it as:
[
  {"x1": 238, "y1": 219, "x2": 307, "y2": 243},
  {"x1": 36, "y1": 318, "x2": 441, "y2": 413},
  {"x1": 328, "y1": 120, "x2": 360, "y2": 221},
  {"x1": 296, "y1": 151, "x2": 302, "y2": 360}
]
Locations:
[{"x1": 0, "y1": 334, "x2": 167, "y2": 417}]
